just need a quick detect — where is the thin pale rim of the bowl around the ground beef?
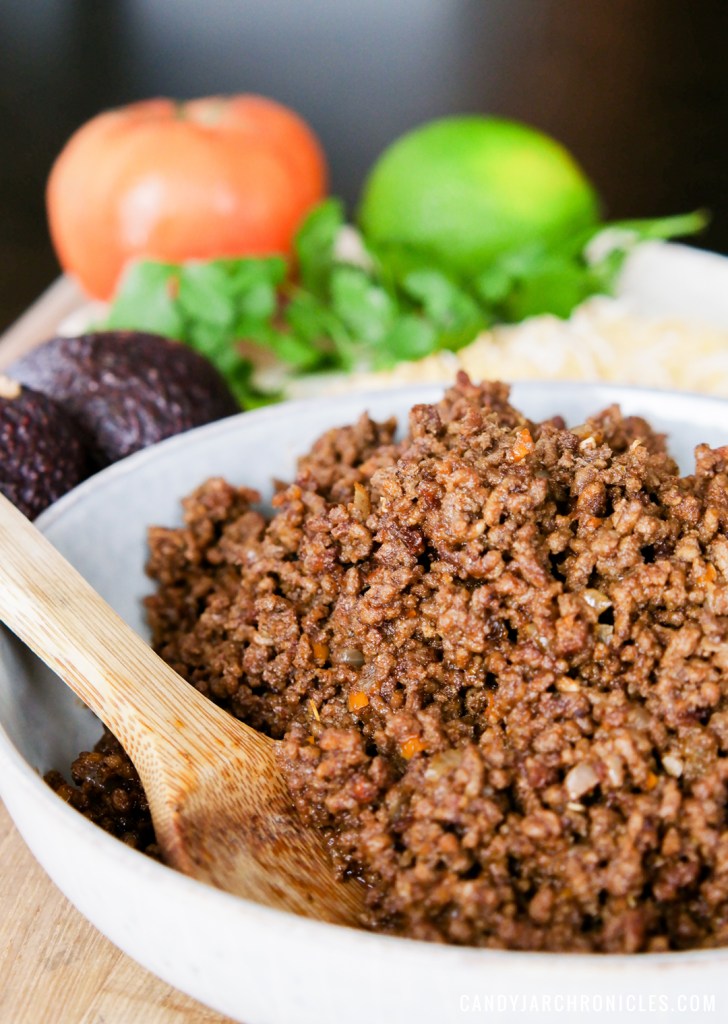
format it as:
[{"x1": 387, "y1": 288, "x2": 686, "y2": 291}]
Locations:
[{"x1": 0, "y1": 380, "x2": 728, "y2": 971}]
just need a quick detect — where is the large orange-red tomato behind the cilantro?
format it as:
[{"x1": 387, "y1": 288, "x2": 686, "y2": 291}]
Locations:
[{"x1": 46, "y1": 95, "x2": 327, "y2": 299}]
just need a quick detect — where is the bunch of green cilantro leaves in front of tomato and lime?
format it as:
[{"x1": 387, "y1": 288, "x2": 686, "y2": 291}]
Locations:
[{"x1": 105, "y1": 199, "x2": 706, "y2": 408}]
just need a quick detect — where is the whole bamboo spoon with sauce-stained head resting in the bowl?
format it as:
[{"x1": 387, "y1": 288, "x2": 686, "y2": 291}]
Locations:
[{"x1": 0, "y1": 495, "x2": 363, "y2": 925}]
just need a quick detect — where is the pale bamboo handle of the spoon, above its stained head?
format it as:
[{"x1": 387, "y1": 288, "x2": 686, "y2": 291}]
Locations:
[{"x1": 0, "y1": 495, "x2": 221, "y2": 758}]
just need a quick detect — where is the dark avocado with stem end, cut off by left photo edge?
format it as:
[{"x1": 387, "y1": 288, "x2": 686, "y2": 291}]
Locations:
[{"x1": 0, "y1": 376, "x2": 93, "y2": 519}]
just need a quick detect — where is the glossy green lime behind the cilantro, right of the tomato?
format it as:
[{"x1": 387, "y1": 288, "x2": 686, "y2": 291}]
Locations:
[{"x1": 358, "y1": 115, "x2": 599, "y2": 273}]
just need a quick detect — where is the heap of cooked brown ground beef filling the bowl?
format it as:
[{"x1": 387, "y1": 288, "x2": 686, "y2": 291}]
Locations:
[{"x1": 47, "y1": 375, "x2": 728, "y2": 952}]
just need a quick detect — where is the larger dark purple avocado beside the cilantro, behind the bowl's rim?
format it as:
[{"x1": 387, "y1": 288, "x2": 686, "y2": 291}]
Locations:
[{"x1": 9, "y1": 331, "x2": 240, "y2": 465}]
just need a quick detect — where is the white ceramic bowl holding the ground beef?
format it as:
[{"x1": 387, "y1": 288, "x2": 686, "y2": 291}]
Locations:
[{"x1": 0, "y1": 383, "x2": 728, "y2": 1024}]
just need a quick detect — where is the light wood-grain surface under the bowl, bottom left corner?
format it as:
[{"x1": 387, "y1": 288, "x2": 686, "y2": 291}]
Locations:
[{"x1": 0, "y1": 803, "x2": 231, "y2": 1024}]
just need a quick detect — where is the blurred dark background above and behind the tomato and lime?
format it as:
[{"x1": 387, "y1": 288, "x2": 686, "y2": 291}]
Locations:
[{"x1": 0, "y1": 0, "x2": 728, "y2": 330}]
